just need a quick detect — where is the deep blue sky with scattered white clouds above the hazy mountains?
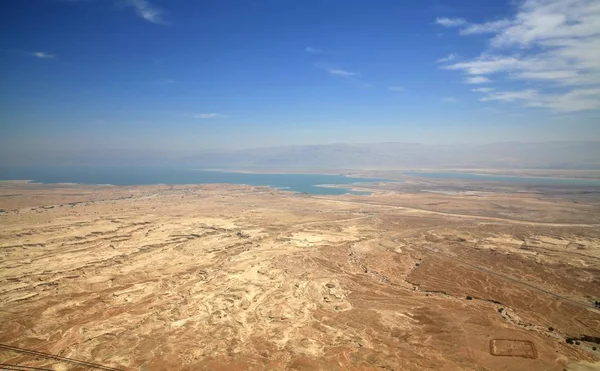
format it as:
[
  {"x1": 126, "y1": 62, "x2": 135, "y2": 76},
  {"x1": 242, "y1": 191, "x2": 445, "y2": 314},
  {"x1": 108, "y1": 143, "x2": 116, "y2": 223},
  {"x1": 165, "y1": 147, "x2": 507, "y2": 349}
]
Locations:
[{"x1": 0, "y1": 0, "x2": 600, "y2": 152}]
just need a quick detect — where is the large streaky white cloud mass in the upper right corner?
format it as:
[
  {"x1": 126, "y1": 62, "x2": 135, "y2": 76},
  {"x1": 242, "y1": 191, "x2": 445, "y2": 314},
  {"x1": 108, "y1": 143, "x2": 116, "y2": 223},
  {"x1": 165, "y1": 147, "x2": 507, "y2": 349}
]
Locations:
[{"x1": 436, "y1": 0, "x2": 600, "y2": 111}]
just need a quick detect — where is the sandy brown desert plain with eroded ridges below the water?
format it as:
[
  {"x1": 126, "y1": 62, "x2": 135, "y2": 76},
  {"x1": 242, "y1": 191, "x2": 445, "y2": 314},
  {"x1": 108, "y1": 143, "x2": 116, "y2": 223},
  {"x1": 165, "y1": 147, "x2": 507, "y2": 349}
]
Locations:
[{"x1": 0, "y1": 178, "x2": 600, "y2": 371}]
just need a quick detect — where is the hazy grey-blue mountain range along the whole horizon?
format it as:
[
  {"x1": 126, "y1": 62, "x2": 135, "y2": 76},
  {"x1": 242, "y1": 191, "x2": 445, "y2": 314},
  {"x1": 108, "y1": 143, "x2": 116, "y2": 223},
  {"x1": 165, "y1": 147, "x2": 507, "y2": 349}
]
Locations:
[{"x1": 0, "y1": 142, "x2": 600, "y2": 169}]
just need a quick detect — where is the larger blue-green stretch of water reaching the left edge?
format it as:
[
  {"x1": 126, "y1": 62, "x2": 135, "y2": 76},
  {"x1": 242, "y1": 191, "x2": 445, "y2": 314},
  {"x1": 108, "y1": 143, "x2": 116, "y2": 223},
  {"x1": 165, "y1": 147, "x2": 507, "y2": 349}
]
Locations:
[{"x1": 0, "y1": 166, "x2": 381, "y2": 195}]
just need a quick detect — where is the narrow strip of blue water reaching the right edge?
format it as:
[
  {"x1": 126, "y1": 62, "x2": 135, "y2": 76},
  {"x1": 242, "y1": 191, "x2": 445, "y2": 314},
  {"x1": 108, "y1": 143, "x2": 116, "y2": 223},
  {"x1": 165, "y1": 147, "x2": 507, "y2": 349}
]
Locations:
[{"x1": 405, "y1": 172, "x2": 600, "y2": 187}]
